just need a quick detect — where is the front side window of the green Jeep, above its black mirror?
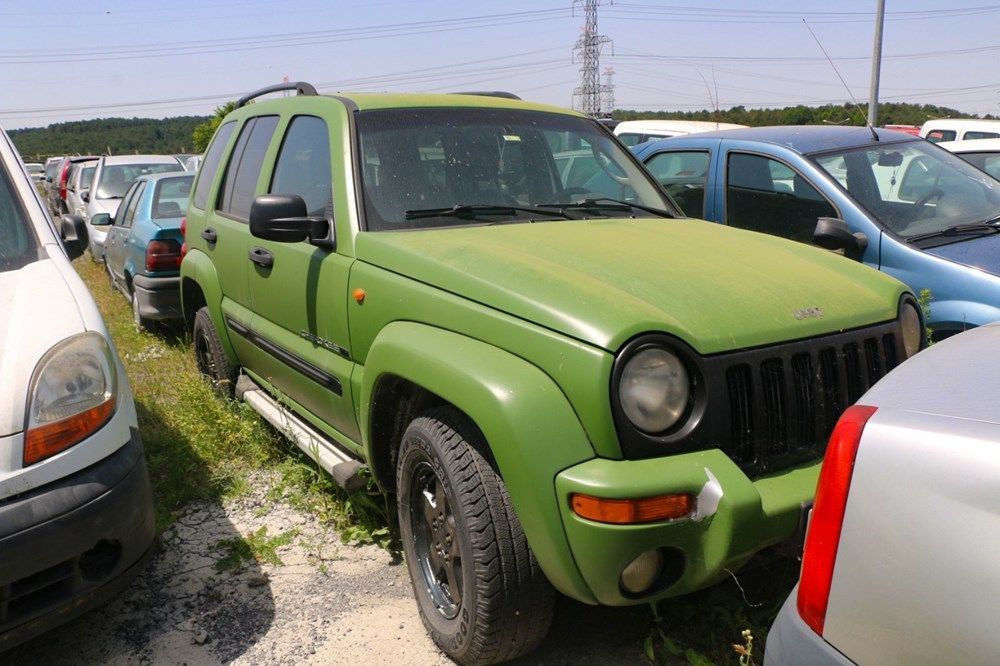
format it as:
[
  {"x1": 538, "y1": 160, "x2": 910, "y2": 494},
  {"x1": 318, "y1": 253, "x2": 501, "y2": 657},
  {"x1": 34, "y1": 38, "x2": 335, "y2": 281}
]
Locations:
[{"x1": 270, "y1": 116, "x2": 333, "y2": 217}]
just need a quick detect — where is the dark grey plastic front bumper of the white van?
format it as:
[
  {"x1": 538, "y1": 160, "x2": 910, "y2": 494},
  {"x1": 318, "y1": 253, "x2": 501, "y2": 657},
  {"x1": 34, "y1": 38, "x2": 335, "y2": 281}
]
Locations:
[{"x1": 0, "y1": 429, "x2": 156, "y2": 652}]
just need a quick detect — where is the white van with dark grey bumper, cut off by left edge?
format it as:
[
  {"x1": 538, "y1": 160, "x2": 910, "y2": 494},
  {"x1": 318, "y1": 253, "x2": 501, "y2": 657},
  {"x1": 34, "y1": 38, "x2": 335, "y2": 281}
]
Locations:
[{"x1": 0, "y1": 126, "x2": 156, "y2": 648}]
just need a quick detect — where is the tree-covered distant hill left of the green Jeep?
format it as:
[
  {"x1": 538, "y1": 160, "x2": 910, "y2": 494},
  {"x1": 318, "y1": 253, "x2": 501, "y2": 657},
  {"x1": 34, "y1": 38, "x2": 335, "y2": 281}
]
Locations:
[{"x1": 8, "y1": 116, "x2": 208, "y2": 162}]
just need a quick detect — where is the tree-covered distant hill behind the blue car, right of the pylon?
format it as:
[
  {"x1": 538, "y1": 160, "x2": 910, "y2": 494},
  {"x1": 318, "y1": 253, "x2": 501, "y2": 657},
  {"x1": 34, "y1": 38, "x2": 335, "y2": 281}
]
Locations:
[{"x1": 612, "y1": 102, "x2": 995, "y2": 127}]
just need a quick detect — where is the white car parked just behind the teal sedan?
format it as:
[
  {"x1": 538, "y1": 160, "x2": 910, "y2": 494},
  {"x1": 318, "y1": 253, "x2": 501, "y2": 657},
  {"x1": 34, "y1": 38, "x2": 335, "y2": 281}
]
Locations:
[{"x1": 83, "y1": 155, "x2": 184, "y2": 261}]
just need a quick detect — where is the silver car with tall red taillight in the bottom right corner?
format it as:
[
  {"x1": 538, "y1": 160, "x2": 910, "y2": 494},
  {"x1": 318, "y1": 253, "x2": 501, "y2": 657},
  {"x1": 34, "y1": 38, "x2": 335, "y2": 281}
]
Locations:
[{"x1": 764, "y1": 323, "x2": 1000, "y2": 666}]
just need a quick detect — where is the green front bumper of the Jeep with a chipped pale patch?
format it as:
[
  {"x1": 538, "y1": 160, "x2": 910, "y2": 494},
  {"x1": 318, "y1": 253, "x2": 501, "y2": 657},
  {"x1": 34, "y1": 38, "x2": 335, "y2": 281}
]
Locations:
[{"x1": 555, "y1": 449, "x2": 822, "y2": 606}]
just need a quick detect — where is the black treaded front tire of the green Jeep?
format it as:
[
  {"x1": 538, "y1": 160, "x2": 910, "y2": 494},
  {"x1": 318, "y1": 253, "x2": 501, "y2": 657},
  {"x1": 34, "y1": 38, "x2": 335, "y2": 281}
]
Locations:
[{"x1": 396, "y1": 408, "x2": 555, "y2": 665}]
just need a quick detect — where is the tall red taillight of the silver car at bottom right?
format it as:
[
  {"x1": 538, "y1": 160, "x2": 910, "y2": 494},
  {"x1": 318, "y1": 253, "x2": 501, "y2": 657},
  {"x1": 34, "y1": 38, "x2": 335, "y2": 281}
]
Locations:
[{"x1": 797, "y1": 405, "x2": 876, "y2": 636}]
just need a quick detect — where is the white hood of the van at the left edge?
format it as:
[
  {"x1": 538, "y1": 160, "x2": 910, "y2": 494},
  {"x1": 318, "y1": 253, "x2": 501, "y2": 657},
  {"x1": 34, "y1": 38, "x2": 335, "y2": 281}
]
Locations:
[{"x1": 0, "y1": 259, "x2": 85, "y2": 436}]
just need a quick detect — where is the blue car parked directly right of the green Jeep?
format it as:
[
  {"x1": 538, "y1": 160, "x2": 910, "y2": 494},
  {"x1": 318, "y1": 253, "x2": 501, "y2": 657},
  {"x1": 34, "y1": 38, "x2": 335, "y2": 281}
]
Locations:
[{"x1": 632, "y1": 126, "x2": 1000, "y2": 338}]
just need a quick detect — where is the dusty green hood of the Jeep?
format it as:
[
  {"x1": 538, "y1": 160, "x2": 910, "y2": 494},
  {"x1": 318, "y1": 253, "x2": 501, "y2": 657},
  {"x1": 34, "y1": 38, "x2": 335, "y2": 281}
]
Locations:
[{"x1": 356, "y1": 219, "x2": 906, "y2": 354}]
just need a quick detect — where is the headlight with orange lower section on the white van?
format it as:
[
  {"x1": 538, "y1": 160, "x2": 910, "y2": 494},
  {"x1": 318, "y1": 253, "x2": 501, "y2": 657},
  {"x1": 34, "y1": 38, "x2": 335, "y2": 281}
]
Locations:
[{"x1": 24, "y1": 332, "x2": 118, "y2": 466}]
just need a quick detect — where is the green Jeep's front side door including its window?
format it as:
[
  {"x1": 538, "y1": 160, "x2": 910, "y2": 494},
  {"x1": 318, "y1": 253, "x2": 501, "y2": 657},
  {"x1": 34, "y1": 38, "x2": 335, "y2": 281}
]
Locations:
[{"x1": 248, "y1": 115, "x2": 360, "y2": 442}]
